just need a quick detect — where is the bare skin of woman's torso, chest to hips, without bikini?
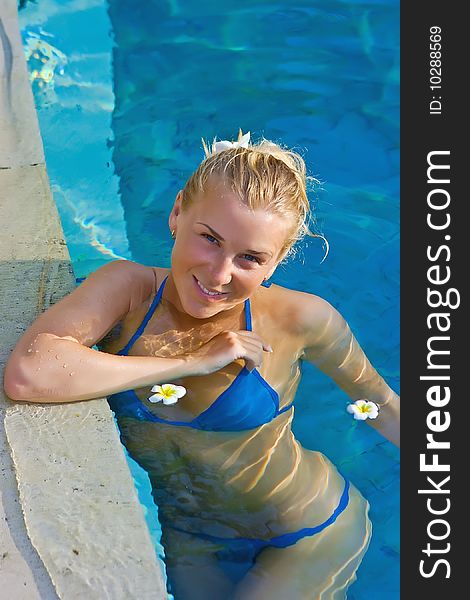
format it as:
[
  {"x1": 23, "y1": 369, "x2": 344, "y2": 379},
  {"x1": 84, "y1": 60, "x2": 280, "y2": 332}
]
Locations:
[{"x1": 99, "y1": 268, "x2": 344, "y2": 537}]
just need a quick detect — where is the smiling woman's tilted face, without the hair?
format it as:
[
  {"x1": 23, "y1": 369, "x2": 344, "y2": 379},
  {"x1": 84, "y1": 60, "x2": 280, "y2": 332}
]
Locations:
[{"x1": 169, "y1": 177, "x2": 292, "y2": 319}]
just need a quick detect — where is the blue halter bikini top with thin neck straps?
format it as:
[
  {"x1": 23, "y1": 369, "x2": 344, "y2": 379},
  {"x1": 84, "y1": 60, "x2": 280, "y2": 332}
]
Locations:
[{"x1": 108, "y1": 276, "x2": 292, "y2": 431}]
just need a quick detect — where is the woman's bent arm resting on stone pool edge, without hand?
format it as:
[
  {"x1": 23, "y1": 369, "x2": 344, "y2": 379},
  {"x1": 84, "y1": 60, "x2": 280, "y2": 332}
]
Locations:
[{"x1": 4, "y1": 261, "x2": 189, "y2": 402}]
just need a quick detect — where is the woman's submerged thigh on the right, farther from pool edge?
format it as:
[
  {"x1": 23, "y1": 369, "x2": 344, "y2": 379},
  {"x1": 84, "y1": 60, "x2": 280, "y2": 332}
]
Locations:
[{"x1": 233, "y1": 486, "x2": 371, "y2": 600}]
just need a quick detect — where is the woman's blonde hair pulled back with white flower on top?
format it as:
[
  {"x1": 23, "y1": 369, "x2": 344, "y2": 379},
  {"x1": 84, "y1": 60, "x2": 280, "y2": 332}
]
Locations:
[{"x1": 182, "y1": 129, "x2": 328, "y2": 262}]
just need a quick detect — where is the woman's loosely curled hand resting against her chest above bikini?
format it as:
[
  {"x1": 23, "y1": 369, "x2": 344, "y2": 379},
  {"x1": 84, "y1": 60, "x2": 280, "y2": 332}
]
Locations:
[{"x1": 187, "y1": 329, "x2": 272, "y2": 375}]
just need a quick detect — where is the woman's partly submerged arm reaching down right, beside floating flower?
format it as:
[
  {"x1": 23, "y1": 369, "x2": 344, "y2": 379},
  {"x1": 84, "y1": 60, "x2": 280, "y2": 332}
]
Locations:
[{"x1": 298, "y1": 294, "x2": 400, "y2": 447}]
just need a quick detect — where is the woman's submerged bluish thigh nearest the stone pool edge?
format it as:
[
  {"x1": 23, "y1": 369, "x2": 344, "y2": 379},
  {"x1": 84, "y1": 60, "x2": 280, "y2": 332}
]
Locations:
[{"x1": 162, "y1": 528, "x2": 234, "y2": 600}]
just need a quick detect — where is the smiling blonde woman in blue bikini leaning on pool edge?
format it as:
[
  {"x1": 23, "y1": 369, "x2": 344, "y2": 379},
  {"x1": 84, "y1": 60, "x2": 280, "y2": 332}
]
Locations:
[{"x1": 5, "y1": 132, "x2": 399, "y2": 600}]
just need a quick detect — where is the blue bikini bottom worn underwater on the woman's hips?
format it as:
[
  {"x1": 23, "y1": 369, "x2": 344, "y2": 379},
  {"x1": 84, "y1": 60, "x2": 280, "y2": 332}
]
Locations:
[{"x1": 168, "y1": 479, "x2": 349, "y2": 580}]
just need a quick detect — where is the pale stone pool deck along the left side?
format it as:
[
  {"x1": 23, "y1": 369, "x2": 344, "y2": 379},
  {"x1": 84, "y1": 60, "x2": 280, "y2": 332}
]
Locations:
[{"x1": 0, "y1": 0, "x2": 167, "y2": 600}]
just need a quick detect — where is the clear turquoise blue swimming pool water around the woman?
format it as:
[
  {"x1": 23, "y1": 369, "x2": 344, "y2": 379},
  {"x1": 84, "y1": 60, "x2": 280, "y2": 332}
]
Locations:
[{"x1": 21, "y1": 0, "x2": 399, "y2": 600}]
